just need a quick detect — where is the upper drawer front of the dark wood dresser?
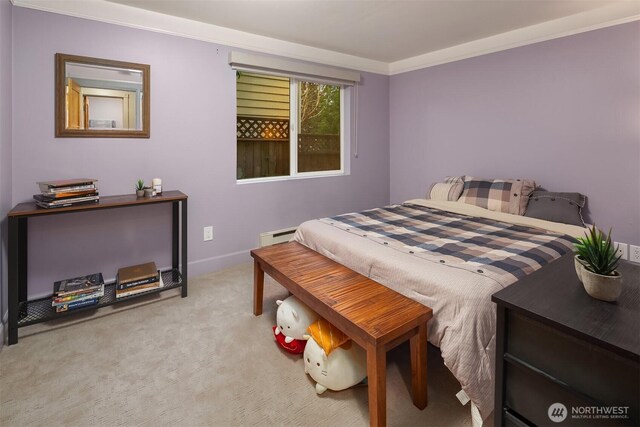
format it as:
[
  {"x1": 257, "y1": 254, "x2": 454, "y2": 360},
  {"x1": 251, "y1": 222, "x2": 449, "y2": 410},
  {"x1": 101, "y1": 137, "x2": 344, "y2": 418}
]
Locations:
[{"x1": 505, "y1": 311, "x2": 640, "y2": 420}]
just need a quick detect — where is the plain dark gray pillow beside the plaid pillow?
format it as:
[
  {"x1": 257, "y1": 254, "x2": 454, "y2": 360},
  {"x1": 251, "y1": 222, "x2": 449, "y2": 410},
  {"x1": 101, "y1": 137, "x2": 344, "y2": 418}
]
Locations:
[{"x1": 524, "y1": 191, "x2": 586, "y2": 227}]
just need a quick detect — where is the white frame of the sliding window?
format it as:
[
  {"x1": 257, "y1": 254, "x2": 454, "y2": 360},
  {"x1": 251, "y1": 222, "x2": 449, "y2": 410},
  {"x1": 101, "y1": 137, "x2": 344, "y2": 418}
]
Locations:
[{"x1": 236, "y1": 77, "x2": 353, "y2": 184}]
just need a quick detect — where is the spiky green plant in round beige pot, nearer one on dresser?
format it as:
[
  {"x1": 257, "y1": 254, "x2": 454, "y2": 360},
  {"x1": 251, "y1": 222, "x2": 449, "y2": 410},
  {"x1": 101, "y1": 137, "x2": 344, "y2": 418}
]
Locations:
[{"x1": 575, "y1": 224, "x2": 622, "y2": 301}]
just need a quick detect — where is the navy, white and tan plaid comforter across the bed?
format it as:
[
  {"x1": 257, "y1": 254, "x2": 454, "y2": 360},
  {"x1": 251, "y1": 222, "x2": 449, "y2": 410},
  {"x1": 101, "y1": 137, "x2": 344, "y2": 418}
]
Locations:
[{"x1": 321, "y1": 203, "x2": 574, "y2": 287}]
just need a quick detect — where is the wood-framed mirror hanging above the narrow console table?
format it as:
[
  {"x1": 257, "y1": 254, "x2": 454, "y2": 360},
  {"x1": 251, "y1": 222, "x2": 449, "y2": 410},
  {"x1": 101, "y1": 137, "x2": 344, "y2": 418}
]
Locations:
[{"x1": 55, "y1": 53, "x2": 150, "y2": 138}]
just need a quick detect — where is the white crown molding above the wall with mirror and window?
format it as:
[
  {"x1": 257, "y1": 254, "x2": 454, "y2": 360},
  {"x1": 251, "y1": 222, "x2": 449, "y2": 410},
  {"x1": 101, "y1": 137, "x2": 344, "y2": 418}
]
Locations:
[{"x1": 10, "y1": 0, "x2": 389, "y2": 75}]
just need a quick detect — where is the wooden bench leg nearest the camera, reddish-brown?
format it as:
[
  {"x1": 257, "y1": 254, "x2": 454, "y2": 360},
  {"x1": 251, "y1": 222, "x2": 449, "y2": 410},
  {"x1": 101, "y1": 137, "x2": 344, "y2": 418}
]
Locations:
[{"x1": 367, "y1": 344, "x2": 387, "y2": 427}]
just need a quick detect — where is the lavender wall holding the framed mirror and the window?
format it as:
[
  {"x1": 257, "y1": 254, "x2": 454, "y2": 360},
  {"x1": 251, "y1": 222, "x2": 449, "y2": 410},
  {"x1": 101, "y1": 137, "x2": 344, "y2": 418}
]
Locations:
[{"x1": 12, "y1": 7, "x2": 389, "y2": 295}]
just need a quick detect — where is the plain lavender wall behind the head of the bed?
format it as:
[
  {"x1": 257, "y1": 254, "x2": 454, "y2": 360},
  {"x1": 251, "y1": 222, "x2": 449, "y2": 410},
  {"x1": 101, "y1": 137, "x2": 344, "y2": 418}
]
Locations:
[{"x1": 390, "y1": 22, "x2": 640, "y2": 245}]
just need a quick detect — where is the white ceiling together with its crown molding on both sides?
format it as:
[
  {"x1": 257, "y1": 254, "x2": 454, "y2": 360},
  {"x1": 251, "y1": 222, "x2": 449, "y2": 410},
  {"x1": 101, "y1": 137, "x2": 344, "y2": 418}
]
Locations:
[{"x1": 12, "y1": 0, "x2": 640, "y2": 75}]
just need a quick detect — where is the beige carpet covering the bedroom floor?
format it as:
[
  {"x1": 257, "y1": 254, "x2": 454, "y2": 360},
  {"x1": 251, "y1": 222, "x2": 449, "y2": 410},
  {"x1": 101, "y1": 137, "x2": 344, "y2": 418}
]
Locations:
[{"x1": 0, "y1": 264, "x2": 471, "y2": 426}]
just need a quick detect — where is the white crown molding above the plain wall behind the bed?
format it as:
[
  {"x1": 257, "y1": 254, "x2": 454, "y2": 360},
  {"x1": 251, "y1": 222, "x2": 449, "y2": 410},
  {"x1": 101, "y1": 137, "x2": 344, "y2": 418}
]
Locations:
[{"x1": 389, "y1": 0, "x2": 640, "y2": 75}]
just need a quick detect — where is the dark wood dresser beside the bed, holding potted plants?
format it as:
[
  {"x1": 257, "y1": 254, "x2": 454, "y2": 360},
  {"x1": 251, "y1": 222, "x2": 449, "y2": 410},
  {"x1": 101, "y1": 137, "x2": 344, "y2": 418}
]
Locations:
[{"x1": 491, "y1": 255, "x2": 640, "y2": 426}]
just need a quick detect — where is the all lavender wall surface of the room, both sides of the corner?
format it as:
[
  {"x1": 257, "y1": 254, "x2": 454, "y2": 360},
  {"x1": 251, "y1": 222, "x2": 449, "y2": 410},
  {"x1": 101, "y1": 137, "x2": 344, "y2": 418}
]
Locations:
[{"x1": 6, "y1": 6, "x2": 640, "y2": 310}]
